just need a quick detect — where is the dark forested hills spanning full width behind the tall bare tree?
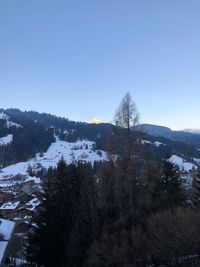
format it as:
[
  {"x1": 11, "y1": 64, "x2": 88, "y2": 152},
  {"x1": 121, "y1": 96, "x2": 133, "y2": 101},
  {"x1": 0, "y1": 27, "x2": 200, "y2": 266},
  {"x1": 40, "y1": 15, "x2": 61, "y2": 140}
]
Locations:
[{"x1": 0, "y1": 109, "x2": 200, "y2": 170}]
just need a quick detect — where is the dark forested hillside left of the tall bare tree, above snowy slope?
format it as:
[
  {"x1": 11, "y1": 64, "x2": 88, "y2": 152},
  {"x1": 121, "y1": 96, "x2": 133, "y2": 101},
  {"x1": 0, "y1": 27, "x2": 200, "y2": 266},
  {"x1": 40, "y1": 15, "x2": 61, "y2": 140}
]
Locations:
[{"x1": 0, "y1": 109, "x2": 111, "y2": 166}]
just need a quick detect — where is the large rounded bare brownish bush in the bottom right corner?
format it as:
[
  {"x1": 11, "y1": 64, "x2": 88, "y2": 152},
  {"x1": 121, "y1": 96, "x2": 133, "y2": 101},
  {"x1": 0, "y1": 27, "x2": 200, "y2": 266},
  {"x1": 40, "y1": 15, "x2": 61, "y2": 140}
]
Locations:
[{"x1": 147, "y1": 208, "x2": 200, "y2": 263}]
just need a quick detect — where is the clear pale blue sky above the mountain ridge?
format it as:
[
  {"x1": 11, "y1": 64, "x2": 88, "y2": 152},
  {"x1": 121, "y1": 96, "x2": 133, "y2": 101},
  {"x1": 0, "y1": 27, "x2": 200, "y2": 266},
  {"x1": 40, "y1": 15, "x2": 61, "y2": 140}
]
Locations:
[{"x1": 0, "y1": 0, "x2": 200, "y2": 129}]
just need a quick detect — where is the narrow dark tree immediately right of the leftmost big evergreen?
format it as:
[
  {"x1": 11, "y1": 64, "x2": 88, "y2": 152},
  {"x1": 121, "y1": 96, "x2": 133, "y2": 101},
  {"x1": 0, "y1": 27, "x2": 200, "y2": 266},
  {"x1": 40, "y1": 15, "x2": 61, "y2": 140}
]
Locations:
[{"x1": 67, "y1": 163, "x2": 98, "y2": 267}]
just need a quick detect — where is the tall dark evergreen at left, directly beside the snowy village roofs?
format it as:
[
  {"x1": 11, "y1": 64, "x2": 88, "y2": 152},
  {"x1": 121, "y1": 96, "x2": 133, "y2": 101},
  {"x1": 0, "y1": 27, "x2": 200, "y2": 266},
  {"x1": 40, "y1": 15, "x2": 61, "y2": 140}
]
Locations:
[{"x1": 27, "y1": 160, "x2": 72, "y2": 267}]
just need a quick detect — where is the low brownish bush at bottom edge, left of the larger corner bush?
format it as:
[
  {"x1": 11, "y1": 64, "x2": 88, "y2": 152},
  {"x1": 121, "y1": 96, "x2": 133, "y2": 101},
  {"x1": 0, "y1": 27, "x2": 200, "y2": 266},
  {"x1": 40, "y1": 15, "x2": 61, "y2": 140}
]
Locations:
[{"x1": 88, "y1": 229, "x2": 147, "y2": 267}]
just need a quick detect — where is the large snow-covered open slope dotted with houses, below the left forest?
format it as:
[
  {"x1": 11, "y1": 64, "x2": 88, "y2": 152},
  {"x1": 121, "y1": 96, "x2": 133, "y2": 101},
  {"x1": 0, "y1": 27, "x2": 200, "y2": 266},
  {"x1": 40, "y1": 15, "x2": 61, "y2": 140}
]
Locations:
[{"x1": 0, "y1": 138, "x2": 107, "y2": 179}]
